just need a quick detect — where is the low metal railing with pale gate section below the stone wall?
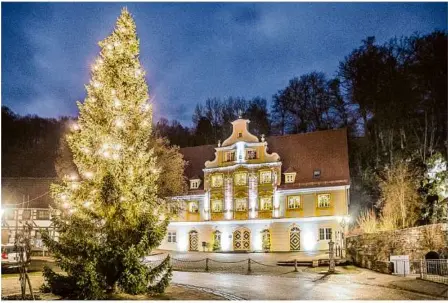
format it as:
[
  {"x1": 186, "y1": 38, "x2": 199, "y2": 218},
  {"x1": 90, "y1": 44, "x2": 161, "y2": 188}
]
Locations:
[{"x1": 392, "y1": 259, "x2": 448, "y2": 284}]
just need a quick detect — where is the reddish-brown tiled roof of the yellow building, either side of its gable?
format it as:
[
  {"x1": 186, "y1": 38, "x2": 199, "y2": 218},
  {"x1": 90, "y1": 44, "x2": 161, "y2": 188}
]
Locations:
[{"x1": 180, "y1": 128, "x2": 350, "y2": 188}]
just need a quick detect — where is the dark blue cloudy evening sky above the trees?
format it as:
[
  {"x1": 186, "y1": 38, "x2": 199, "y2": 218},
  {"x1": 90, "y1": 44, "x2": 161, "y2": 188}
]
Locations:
[{"x1": 1, "y1": 3, "x2": 447, "y2": 124}]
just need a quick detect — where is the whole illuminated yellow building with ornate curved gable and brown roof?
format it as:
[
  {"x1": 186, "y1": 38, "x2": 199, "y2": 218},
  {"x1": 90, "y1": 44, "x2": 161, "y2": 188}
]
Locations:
[{"x1": 160, "y1": 118, "x2": 350, "y2": 251}]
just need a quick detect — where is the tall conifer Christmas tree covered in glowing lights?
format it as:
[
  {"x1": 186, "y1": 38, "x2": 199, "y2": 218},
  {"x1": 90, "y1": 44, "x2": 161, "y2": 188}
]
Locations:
[{"x1": 44, "y1": 9, "x2": 175, "y2": 299}]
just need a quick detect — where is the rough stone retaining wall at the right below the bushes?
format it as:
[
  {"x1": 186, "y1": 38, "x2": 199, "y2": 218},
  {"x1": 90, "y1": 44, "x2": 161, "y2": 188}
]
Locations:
[{"x1": 346, "y1": 223, "x2": 448, "y2": 273}]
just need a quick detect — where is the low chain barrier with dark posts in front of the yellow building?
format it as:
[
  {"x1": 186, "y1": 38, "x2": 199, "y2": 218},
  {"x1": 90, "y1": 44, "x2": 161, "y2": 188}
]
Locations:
[{"x1": 145, "y1": 256, "x2": 299, "y2": 274}]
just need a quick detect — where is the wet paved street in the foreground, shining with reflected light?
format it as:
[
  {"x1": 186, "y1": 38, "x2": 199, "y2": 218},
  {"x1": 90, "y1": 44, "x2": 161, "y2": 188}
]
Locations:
[{"x1": 173, "y1": 272, "x2": 444, "y2": 300}]
